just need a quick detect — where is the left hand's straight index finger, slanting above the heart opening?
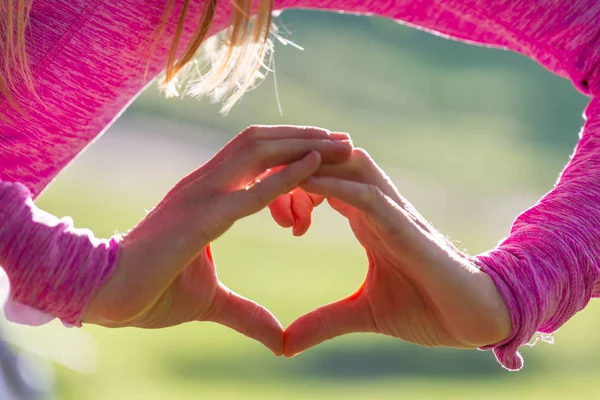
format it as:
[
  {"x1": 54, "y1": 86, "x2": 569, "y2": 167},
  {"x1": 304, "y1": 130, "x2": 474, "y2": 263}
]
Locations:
[{"x1": 226, "y1": 151, "x2": 321, "y2": 220}]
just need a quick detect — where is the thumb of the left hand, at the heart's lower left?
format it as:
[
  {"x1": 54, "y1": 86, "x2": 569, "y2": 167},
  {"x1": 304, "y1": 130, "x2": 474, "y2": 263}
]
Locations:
[{"x1": 203, "y1": 284, "x2": 283, "y2": 356}]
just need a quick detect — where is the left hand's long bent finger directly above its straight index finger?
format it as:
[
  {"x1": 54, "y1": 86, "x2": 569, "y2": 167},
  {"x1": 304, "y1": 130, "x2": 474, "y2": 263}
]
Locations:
[{"x1": 202, "y1": 139, "x2": 352, "y2": 192}]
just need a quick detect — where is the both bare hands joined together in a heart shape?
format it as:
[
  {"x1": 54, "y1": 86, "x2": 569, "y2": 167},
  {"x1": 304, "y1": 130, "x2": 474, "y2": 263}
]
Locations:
[{"x1": 84, "y1": 127, "x2": 511, "y2": 357}]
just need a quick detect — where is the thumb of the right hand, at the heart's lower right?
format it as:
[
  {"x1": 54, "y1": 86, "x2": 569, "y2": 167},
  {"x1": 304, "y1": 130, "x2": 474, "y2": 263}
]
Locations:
[{"x1": 283, "y1": 297, "x2": 377, "y2": 357}]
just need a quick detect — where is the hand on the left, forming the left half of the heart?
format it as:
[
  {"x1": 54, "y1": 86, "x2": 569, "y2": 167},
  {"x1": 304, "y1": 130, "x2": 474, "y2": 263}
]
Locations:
[{"x1": 84, "y1": 126, "x2": 352, "y2": 355}]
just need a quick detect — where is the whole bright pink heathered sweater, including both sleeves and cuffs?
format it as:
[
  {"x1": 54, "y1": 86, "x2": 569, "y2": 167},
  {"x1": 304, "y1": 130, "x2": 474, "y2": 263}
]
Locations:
[{"x1": 0, "y1": 0, "x2": 600, "y2": 369}]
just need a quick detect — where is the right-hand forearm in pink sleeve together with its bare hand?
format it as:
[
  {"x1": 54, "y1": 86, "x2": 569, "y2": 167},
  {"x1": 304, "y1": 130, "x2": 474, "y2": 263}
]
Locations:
[{"x1": 284, "y1": 108, "x2": 600, "y2": 370}]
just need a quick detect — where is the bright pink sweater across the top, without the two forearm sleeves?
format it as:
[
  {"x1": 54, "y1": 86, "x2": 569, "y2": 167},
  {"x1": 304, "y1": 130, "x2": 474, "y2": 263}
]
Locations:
[{"x1": 0, "y1": 0, "x2": 600, "y2": 197}]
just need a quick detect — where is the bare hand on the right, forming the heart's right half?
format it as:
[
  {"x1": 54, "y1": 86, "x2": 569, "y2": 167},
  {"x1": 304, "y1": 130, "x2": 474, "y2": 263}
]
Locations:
[{"x1": 284, "y1": 149, "x2": 511, "y2": 357}]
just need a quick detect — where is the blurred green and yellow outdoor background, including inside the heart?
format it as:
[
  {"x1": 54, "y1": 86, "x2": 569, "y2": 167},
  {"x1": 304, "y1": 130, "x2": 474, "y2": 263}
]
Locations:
[{"x1": 6, "y1": 11, "x2": 600, "y2": 400}]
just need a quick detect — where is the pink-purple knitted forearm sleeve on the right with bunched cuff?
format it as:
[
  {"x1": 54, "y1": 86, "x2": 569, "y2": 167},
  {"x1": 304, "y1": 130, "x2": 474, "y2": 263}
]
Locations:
[{"x1": 474, "y1": 99, "x2": 600, "y2": 370}]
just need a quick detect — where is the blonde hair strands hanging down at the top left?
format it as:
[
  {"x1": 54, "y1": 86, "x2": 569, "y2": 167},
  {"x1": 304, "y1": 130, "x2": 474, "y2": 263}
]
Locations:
[{"x1": 0, "y1": 0, "x2": 273, "y2": 112}]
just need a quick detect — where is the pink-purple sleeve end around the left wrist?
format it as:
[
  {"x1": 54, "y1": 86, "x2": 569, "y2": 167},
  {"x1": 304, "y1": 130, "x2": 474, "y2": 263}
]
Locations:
[{"x1": 0, "y1": 181, "x2": 119, "y2": 326}]
